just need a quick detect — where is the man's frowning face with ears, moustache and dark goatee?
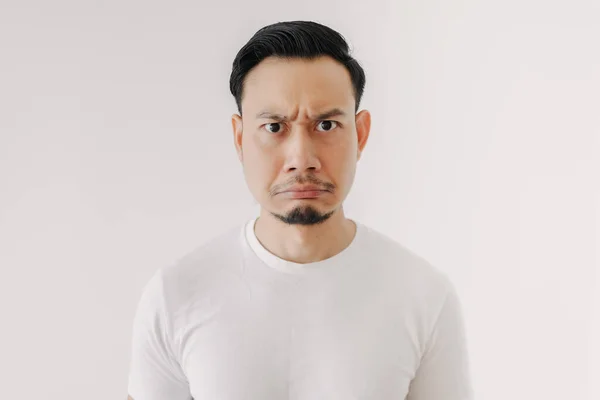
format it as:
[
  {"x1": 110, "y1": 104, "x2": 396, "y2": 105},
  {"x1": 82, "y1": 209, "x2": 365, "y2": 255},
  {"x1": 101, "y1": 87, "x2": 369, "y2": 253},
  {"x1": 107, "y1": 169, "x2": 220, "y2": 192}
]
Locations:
[{"x1": 232, "y1": 57, "x2": 370, "y2": 225}]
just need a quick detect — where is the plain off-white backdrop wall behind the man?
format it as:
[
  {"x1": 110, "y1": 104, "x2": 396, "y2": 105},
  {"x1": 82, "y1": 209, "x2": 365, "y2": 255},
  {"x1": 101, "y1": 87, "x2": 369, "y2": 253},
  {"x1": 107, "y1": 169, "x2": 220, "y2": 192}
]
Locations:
[{"x1": 0, "y1": 0, "x2": 600, "y2": 400}]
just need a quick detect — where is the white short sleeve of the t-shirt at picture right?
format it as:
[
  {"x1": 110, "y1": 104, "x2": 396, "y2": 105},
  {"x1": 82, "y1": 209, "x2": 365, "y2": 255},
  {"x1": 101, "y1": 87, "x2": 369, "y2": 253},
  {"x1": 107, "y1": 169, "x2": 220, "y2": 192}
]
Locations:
[{"x1": 406, "y1": 281, "x2": 473, "y2": 400}]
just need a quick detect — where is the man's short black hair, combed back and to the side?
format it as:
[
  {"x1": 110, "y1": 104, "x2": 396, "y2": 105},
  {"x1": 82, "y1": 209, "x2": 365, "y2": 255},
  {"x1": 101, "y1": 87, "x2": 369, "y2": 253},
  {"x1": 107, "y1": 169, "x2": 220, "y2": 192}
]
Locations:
[{"x1": 229, "y1": 21, "x2": 365, "y2": 115}]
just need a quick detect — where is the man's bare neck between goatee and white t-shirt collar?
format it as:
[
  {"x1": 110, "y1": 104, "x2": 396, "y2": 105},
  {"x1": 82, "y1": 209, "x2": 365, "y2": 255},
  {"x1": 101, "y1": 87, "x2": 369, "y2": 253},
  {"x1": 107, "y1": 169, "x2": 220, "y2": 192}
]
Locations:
[{"x1": 254, "y1": 207, "x2": 356, "y2": 264}]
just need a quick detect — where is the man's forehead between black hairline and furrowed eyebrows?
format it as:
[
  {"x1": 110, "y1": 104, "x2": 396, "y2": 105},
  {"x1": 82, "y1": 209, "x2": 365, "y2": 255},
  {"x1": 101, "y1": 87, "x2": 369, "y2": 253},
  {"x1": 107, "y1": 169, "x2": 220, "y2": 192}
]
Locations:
[{"x1": 242, "y1": 57, "x2": 355, "y2": 115}]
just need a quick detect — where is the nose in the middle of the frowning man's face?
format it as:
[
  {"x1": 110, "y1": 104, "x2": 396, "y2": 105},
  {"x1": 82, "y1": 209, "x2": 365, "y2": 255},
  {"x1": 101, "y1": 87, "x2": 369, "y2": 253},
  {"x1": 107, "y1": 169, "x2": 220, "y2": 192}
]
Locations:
[{"x1": 284, "y1": 127, "x2": 321, "y2": 173}]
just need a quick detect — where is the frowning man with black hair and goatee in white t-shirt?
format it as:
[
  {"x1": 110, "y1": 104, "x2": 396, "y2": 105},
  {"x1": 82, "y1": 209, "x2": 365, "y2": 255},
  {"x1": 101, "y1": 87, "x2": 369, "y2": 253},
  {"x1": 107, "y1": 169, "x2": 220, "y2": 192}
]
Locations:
[{"x1": 128, "y1": 21, "x2": 472, "y2": 400}]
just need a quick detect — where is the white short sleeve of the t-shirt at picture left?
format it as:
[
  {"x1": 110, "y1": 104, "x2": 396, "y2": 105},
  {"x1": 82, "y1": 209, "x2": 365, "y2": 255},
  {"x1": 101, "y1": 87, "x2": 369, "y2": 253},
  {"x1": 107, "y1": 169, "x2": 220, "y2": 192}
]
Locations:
[{"x1": 127, "y1": 269, "x2": 192, "y2": 400}]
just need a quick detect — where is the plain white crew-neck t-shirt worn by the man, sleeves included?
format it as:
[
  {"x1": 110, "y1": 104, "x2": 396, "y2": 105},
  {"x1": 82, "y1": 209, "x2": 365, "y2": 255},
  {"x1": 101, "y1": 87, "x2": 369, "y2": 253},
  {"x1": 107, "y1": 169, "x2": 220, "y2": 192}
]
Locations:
[{"x1": 128, "y1": 219, "x2": 472, "y2": 400}]
